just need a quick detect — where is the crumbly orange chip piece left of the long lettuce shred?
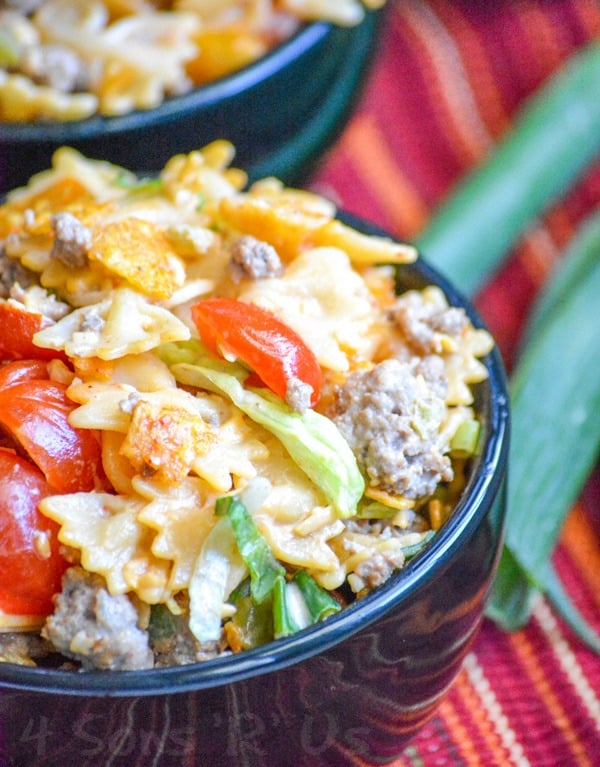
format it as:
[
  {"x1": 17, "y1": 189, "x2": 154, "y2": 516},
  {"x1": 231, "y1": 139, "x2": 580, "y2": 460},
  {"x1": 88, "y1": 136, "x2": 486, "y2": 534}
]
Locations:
[{"x1": 120, "y1": 400, "x2": 216, "y2": 483}]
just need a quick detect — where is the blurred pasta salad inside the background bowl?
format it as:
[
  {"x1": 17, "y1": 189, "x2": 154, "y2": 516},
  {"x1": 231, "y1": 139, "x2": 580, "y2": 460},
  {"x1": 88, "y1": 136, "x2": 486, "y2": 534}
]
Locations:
[{"x1": 0, "y1": 0, "x2": 385, "y2": 122}]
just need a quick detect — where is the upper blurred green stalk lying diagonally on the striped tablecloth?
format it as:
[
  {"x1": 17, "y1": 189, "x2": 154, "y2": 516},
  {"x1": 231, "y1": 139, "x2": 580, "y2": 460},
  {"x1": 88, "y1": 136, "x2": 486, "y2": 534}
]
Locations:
[{"x1": 414, "y1": 42, "x2": 600, "y2": 294}]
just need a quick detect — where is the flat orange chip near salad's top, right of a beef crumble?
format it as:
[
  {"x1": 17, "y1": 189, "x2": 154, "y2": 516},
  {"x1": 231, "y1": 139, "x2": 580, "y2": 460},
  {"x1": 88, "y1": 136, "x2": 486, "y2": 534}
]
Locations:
[{"x1": 89, "y1": 218, "x2": 185, "y2": 299}]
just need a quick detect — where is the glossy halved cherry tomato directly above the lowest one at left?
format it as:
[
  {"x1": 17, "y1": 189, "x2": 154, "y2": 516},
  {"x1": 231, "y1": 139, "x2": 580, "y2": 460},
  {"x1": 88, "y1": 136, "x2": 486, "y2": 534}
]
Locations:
[{"x1": 0, "y1": 372, "x2": 103, "y2": 493}]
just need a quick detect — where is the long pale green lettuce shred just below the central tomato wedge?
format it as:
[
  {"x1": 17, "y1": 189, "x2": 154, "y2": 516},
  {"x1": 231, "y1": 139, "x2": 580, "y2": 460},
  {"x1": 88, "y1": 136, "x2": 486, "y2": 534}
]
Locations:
[{"x1": 171, "y1": 355, "x2": 364, "y2": 517}]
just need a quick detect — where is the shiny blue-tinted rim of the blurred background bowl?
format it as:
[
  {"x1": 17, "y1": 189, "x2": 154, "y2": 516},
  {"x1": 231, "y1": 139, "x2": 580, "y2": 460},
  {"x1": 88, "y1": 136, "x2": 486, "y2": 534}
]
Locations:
[{"x1": 0, "y1": 21, "x2": 336, "y2": 144}]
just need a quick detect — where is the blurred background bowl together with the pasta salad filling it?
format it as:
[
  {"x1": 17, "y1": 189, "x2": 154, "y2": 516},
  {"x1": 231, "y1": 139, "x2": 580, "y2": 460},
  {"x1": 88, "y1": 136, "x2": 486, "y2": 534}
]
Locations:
[{"x1": 0, "y1": 0, "x2": 384, "y2": 192}]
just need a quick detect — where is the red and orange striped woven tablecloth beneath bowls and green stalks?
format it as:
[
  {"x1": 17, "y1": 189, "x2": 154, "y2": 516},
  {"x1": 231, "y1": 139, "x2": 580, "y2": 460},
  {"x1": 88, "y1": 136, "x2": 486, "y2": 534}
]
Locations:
[{"x1": 312, "y1": 0, "x2": 600, "y2": 767}]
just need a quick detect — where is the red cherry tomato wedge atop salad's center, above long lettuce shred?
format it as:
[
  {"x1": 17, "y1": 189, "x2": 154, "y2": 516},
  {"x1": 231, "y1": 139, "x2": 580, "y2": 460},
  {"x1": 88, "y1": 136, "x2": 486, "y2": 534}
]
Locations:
[{"x1": 192, "y1": 298, "x2": 322, "y2": 406}]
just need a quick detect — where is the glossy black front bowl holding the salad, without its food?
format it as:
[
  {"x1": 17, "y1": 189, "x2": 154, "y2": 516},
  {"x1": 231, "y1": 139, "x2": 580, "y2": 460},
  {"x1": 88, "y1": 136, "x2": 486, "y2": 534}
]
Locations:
[{"x1": 0, "y1": 219, "x2": 509, "y2": 767}]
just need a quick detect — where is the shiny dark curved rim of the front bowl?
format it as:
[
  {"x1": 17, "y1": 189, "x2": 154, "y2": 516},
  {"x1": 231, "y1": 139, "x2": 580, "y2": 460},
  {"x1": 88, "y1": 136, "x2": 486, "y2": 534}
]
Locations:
[{"x1": 0, "y1": 219, "x2": 509, "y2": 697}]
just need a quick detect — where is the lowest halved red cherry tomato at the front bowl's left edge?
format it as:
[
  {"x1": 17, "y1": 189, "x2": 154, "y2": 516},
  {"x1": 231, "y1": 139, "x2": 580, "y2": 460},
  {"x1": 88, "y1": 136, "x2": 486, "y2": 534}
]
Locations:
[{"x1": 0, "y1": 448, "x2": 68, "y2": 616}]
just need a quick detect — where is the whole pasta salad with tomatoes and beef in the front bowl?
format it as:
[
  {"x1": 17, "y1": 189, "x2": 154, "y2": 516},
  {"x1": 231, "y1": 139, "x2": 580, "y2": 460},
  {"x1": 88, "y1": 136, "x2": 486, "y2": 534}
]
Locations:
[{"x1": 0, "y1": 141, "x2": 492, "y2": 670}]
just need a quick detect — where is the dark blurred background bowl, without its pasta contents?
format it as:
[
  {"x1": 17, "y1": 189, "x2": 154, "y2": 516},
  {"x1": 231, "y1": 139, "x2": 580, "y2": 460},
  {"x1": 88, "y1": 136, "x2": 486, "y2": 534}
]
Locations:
[{"x1": 0, "y1": 11, "x2": 382, "y2": 194}]
